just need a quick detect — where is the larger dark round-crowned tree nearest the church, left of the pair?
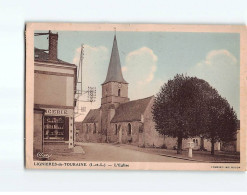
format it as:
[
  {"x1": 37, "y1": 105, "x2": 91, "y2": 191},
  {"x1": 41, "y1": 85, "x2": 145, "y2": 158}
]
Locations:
[{"x1": 152, "y1": 75, "x2": 211, "y2": 154}]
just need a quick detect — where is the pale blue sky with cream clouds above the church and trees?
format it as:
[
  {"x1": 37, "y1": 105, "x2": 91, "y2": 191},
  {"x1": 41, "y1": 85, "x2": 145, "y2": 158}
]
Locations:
[{"x1": 34, "y1": 31, "x2": 240, "y2": 121}]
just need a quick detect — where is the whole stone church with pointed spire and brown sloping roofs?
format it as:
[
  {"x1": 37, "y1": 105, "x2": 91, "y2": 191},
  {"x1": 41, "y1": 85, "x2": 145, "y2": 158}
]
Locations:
[{"x1": 76, "y1": 35, "x2": 224, "y2": 150}]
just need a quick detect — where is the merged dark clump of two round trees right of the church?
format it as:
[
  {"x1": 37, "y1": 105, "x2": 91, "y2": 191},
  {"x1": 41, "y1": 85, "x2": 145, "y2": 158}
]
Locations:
[{"x1": 152, "y1": 75, "x2": 237, "y2": 154}]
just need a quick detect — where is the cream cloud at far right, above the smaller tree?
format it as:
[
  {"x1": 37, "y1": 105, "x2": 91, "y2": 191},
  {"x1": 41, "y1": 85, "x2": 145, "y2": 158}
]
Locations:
[{"x1": 188, "y1": 49, "x2": 240, "y2": 117}]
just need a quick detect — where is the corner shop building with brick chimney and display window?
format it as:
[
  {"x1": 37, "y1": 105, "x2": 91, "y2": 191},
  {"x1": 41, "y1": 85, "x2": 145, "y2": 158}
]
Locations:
[{"x1": 34, "y1": 32, "x2": 77, "y2": 153}]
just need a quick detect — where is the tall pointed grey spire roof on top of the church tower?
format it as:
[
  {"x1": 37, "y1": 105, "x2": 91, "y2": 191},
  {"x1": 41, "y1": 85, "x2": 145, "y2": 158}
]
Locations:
[{"x1": 103, "y1": 35, "x2": 127, "y2": 84}]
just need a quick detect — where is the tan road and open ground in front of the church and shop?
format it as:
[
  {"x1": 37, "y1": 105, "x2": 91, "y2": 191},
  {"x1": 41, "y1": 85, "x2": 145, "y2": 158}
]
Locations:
[{"x1": 36, "y1": 143, "x2": 239, "y2": 163}]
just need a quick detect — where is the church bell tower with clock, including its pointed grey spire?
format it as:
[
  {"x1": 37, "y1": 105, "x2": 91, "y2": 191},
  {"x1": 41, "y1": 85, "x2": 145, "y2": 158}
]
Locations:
[{"x1": 101, "y1": 35, "x2": 129, "y2": 108}]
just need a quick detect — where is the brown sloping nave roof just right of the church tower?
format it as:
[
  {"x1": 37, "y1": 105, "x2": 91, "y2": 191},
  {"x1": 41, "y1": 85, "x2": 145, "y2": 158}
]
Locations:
[{"x1": 111, "y1": 96, "x2": 153, "y2": 123}]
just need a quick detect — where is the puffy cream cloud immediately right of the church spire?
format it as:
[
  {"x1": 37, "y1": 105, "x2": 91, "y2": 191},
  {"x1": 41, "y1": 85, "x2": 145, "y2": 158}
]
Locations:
[{"x1": 122, "y1": 47, "x2": 161, "y2": 100}]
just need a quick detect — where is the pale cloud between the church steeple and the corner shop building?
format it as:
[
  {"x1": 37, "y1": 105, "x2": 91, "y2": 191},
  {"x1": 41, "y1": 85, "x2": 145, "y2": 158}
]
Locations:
[{"x1": 73, "y1": 45, "x2": 109, "y2": 121}]
